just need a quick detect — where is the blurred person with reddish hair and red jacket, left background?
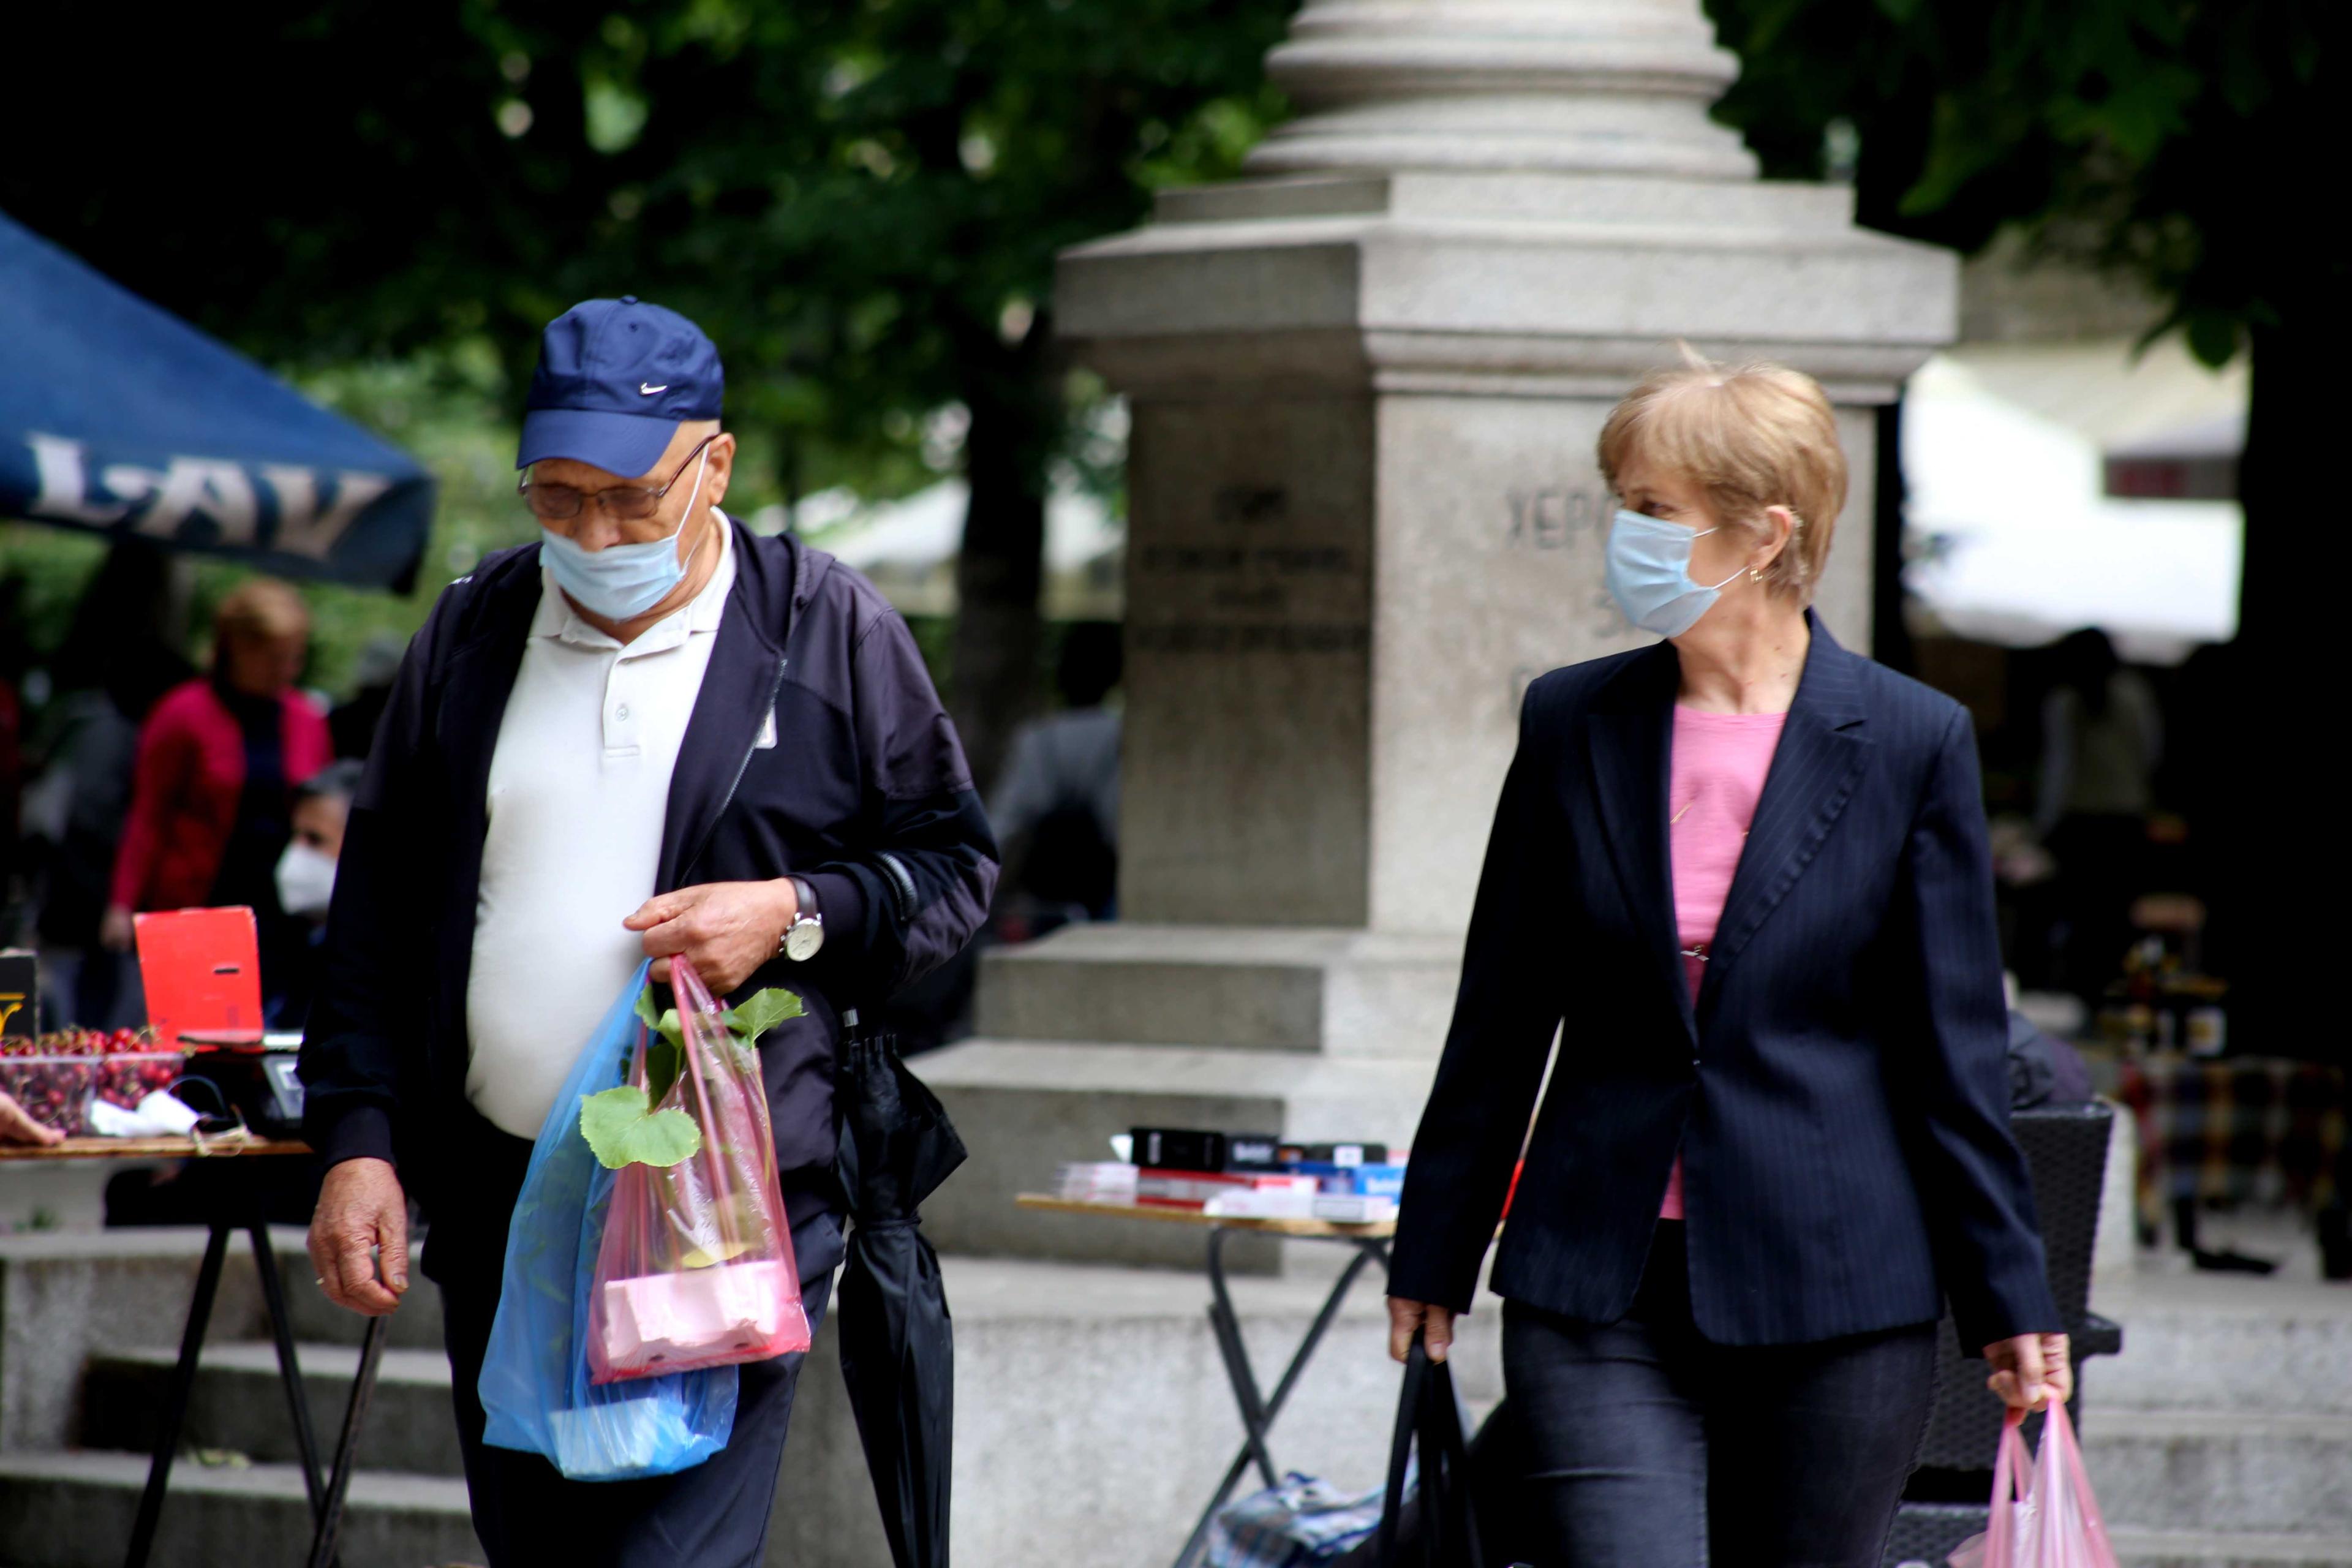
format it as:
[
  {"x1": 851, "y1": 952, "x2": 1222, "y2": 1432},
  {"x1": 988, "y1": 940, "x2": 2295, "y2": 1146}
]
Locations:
[{"x1": 99, "y1": 578, "x2": 334, "y2": 973}]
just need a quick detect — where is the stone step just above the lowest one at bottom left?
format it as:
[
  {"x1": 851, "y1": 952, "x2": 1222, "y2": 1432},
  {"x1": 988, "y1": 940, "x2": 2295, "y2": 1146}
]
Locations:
[{"x1": 82, "y1": 1343, "x2": 463, "y2": 1476}]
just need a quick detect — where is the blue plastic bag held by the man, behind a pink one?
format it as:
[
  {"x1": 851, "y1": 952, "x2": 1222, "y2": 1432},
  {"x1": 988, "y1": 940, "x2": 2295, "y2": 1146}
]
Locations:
[{"x1": 480, "y1": 964, "x2": 736, "y2": 1481}]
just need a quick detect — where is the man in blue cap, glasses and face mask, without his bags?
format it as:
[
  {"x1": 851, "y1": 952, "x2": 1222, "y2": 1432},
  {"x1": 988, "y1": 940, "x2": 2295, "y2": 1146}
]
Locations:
[{"x1": 301, "y1": 296, "x2": 997, "y2": 1568}]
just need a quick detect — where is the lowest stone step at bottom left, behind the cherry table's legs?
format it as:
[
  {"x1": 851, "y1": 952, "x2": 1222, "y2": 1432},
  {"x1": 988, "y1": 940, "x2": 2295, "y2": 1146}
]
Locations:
[{"x1": 0, "y1": 1450, "x2": 487, "y2": 1568}]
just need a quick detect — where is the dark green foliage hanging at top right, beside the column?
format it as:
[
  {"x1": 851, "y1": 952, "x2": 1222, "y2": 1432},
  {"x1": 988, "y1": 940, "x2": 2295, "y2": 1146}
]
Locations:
[{"x1": 1708, "y1": 0, "x2": 2343, "y2": 364}]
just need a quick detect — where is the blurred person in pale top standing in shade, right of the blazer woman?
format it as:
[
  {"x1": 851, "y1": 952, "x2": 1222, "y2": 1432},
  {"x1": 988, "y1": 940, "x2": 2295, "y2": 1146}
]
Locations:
[{"x1": 2035, "y1": 625, "x2": 2164, "y2": 1006}]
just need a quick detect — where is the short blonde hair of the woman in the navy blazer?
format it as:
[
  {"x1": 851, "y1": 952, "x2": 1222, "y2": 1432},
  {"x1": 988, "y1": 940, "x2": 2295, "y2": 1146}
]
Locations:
[{"x1": 1599, "y1": 348, "x2": 1846, "y2": 604}]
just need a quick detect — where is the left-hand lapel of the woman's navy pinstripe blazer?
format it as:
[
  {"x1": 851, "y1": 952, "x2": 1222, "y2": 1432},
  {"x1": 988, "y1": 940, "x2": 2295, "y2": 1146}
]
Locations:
[{"x1": 1588, "y1": 642, "x2": 1698, "y2": 1039}]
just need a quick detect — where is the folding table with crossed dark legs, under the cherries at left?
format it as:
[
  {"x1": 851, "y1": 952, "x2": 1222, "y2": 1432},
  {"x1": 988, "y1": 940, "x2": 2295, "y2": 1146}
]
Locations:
[{"x1": 0, "y1": 1131, "x2": 390, "y2": 1568}]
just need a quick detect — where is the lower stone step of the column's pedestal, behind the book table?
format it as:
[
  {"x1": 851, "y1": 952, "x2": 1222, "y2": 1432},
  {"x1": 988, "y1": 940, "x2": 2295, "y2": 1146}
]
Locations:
[{"x1": 913, "y1": 1039, "x2": 1434, "y2": 1270}]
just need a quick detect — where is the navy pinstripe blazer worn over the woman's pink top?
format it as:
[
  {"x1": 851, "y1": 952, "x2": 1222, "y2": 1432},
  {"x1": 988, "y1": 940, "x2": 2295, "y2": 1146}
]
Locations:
[{"x1": 1388, "y1": 620, "x2": 2063, "y2": 1352}]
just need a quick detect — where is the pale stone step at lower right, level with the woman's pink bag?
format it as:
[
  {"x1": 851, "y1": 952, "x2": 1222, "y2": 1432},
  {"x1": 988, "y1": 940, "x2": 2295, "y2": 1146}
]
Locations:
[{"x1": 2081, "y1": 1420, "x2": 2352, "y2": 1535}]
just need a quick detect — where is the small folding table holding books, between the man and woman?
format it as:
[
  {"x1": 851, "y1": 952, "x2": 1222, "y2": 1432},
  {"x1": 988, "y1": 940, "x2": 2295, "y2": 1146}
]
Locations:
[{"x1": 1014, "y1": 1192, "x2": 1397, "y2": 1568}]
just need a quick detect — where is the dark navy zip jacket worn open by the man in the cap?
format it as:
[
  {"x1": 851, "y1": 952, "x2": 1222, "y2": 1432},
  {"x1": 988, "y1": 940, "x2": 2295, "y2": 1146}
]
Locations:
[{"x1": 301, "y1": 524, "x2": 997, "y2": 1225}]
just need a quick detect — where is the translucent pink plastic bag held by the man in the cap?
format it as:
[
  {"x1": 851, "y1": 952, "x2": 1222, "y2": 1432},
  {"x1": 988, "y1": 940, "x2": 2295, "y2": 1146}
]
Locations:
[{"x1": 586, "y1": 959, "x2": 809, "y2": 1382}]
